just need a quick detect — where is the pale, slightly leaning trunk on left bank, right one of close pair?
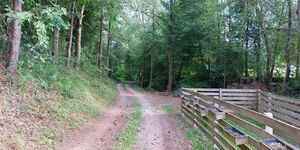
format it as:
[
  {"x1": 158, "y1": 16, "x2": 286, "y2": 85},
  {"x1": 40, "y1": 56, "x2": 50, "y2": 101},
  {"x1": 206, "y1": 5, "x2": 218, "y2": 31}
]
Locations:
[{"x1": 76, "y1": 6, "x2": 84, "y2": 67}]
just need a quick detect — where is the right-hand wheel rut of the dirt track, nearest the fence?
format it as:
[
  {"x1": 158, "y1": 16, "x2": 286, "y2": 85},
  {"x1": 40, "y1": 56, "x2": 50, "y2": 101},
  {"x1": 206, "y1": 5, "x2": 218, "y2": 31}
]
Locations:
[{"x1": 126, "y1": 85, "x2": 191, "y2": 150}]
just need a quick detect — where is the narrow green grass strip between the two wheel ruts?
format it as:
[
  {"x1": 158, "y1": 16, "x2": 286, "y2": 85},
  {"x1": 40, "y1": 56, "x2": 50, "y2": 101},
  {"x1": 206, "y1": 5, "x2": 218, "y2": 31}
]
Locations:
[{"x1": 115, "y1": 103, "x2": 142, "y2": 150}]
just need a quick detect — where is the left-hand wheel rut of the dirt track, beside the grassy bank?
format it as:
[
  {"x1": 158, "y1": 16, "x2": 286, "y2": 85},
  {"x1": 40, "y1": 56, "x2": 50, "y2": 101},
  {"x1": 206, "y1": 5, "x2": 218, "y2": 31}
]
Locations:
[{"x1": 56, "y1": 85, "x2": 133, "y2": 150}]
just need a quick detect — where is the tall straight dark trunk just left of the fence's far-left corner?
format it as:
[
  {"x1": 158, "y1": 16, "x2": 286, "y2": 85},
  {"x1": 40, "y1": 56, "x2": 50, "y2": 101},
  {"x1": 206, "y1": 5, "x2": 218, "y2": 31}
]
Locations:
[{"x1": 167, "y1": 0, "x2": 174, "y2": 92}]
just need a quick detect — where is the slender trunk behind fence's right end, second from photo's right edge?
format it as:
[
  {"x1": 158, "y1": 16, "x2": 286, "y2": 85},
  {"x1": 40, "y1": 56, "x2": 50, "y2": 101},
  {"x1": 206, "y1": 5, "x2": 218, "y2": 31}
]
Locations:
[{"x1": 283, "y1": 0, "x2": 292, "y2": 86}]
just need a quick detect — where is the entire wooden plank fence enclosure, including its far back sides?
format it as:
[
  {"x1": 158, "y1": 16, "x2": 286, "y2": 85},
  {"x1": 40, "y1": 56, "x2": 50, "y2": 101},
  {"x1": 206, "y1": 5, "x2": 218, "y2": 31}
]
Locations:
[{"x1": 181, "y1": 89, "x2": 300, "y2": 150}]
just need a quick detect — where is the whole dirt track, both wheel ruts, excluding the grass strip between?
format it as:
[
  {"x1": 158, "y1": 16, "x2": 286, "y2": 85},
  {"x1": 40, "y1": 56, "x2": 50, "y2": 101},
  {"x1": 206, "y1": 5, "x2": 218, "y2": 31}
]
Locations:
[{"x1": 56, "y1": 85, "x2": 190, "y2": 150}]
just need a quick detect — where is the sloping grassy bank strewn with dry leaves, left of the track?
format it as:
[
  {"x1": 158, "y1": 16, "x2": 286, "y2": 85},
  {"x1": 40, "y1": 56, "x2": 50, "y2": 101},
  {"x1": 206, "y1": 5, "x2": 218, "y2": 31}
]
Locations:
[{"x1": 0, "y1": 59, "x2": 116, "y2": 149}]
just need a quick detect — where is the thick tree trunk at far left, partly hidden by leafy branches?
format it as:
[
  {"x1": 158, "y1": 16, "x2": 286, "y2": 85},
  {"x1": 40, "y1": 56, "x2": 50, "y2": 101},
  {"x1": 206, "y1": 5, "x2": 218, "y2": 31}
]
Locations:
[{"x1": 7, "y1": 0, "x2": 22, "y2": 75}]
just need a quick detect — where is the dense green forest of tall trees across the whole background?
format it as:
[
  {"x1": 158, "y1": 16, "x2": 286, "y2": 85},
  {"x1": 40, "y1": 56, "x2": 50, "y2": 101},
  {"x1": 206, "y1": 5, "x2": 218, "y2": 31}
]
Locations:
[{"x1": 0, "y1": 0, "x2": 300, "y2": 96}]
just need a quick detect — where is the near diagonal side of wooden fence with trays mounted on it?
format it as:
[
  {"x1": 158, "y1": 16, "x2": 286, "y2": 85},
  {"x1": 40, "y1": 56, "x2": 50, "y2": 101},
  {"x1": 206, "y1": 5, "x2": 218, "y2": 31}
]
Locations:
[{"x1": 181, "y1": 89, "x2": 300, "y2": 150}]
